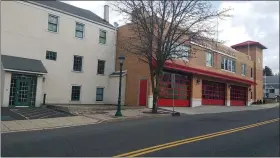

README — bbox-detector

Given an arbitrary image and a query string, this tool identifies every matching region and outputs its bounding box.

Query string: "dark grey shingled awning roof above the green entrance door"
[1,55,47,73]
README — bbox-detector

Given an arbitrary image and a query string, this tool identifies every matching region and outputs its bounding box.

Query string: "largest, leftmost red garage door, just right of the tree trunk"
[157,72,191,106]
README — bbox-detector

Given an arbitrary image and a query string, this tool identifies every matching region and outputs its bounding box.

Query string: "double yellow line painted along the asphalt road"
[115,118,279,157]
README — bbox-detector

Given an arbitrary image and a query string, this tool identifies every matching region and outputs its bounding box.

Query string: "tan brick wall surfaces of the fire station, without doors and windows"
[116,25,263,105]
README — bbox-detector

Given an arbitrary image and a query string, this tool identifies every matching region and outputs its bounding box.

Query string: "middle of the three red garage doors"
[202,80,225,105]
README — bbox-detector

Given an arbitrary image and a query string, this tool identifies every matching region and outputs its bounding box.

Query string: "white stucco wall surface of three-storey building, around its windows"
[1,1,116,104]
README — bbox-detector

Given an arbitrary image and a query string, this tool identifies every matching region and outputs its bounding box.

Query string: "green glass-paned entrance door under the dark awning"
[15,79,31,106]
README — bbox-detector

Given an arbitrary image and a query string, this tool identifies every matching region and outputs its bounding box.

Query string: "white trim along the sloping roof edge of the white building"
[20,1,116,30]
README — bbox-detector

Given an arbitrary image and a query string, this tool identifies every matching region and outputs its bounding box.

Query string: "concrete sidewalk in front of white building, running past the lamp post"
[1,108,168,133]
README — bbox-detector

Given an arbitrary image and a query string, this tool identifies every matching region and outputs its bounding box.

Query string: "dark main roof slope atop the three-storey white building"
[30,0,114,27]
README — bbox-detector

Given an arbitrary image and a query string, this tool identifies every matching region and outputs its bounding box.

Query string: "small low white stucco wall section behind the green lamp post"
[105,75,126,105]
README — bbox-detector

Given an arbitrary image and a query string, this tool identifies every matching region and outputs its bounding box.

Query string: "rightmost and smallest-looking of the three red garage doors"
[230,85,247,106]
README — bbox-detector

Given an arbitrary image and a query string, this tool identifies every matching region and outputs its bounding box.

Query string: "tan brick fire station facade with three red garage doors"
[116,24,266,107]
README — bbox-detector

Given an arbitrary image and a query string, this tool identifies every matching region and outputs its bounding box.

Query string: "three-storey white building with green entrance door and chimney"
[1,1,125,107]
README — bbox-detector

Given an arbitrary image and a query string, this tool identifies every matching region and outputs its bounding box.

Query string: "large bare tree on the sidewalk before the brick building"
[112,0,229,113]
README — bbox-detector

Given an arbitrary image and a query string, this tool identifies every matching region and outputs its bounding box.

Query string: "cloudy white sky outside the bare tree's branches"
[66,1,279,73]
